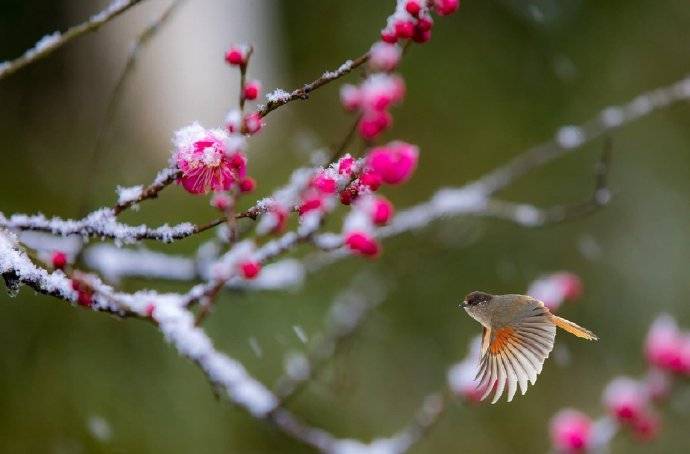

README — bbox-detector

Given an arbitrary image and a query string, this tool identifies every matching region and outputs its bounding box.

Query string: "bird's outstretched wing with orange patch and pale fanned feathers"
[476,300,556,404]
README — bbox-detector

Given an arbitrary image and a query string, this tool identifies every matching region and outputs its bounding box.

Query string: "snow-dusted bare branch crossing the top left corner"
[0,0,143,79]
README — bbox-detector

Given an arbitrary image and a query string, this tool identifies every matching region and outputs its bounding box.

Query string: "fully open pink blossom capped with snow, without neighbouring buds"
[174,124,237,194]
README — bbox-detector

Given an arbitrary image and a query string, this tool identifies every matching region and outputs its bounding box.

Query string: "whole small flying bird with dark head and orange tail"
[460,291,599,404]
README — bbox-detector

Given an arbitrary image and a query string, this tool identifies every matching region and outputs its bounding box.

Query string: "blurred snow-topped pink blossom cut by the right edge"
[645,314,690,374]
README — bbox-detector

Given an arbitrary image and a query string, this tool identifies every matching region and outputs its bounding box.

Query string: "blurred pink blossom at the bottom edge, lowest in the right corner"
[550,408,592,453]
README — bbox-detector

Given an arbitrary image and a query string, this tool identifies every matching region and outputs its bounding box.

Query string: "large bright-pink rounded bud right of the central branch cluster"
[367,142,419,184]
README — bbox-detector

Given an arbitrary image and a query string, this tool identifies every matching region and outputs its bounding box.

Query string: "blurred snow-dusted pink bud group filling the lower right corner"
[551,315,690,453]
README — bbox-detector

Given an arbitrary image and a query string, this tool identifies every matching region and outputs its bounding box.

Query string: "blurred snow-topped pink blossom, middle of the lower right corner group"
[603,377,649,423]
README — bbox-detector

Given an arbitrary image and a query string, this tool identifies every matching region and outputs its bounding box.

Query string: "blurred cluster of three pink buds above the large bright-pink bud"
[340,73,405,140]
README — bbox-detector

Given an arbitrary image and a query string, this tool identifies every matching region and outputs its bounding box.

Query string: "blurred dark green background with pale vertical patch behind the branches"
[0,0,690,453]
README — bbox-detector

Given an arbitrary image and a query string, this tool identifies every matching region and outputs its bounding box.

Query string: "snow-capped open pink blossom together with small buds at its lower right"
[173,123,254,195]
